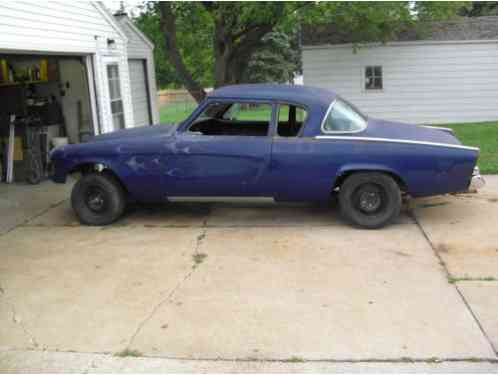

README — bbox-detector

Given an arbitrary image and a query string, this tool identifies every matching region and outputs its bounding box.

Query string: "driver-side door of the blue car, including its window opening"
[163,100,275,198]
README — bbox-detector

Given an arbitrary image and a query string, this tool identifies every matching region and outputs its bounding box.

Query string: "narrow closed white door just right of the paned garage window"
[128,59,152,126]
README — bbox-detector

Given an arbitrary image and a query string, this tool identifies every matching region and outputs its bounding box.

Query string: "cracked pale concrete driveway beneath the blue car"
[0,176,498,372]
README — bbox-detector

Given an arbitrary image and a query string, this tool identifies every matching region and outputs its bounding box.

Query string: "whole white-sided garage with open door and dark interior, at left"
[0,2,159,184]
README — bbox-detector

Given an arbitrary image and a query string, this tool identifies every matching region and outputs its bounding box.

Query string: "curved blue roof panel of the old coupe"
[208,84,336,107]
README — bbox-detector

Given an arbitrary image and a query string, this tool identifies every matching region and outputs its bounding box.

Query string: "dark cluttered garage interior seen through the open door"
[0,54,95,184]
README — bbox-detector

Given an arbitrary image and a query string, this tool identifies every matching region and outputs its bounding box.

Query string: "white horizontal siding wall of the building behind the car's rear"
[303,41,498,123]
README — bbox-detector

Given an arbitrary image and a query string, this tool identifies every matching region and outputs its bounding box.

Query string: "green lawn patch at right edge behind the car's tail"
[441,121,498,174]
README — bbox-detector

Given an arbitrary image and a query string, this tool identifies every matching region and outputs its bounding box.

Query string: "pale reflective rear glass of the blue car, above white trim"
[322,99,367,133]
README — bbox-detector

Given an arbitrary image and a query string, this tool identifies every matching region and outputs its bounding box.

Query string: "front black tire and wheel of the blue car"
[71,173,126,225]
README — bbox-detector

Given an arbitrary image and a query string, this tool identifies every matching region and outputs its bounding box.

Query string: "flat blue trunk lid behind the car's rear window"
[359,118,461,145]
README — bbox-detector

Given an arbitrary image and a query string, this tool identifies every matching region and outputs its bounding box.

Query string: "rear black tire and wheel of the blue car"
[339,172,401,229]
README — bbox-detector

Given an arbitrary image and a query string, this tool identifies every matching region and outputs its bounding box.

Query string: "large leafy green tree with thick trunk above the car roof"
[146,1,462,101]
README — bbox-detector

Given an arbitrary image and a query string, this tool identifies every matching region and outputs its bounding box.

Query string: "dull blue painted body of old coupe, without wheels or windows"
[52,85,478,201]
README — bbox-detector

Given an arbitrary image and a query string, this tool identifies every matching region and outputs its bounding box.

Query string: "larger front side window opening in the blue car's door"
[188,102,272,137]
